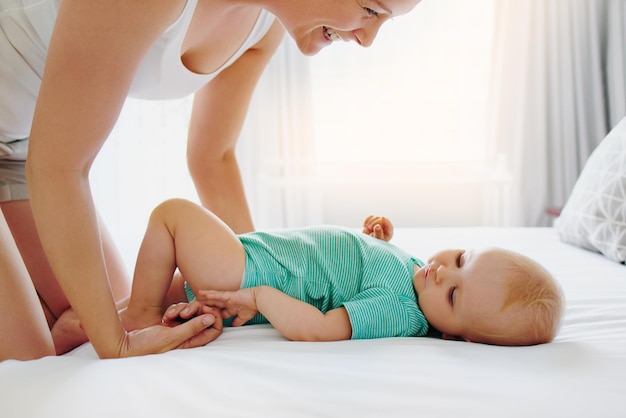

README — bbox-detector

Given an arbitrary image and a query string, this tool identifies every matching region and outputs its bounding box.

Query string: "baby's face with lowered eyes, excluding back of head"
[413,249,508,341]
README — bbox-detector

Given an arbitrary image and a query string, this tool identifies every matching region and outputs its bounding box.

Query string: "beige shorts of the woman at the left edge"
[0,138,28,202]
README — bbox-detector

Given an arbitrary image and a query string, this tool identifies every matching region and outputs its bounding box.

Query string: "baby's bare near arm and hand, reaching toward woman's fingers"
[197,286,352,341]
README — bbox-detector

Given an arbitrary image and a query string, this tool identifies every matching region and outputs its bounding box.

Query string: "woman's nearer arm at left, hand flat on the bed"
[27,0,210,358]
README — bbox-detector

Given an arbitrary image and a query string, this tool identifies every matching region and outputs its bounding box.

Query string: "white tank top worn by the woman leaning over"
[0,0,274,145]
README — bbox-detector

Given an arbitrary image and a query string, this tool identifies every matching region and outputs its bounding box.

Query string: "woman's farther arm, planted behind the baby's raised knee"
[187,21,284,233]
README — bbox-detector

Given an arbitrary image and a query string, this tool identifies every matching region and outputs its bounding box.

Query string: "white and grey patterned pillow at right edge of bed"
[554,118,626,263]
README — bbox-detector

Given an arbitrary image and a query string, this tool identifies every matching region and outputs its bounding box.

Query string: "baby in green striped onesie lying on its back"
[121,199,563,345]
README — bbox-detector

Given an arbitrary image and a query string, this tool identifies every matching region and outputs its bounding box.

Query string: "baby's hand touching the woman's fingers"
[196,288,259,327]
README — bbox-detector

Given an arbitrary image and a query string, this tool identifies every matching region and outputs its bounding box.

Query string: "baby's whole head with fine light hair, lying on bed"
[413,248,563,345]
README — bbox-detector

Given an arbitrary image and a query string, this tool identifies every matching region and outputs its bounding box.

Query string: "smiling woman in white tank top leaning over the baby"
[0,0,419,359]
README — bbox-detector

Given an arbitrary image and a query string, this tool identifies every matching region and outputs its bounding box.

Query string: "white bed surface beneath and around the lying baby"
[0,228,626,418]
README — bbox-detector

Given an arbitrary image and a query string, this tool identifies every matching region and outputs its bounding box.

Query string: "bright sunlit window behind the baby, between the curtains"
[310,0,502,226]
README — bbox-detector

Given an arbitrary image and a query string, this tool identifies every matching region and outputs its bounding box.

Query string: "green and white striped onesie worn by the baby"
[189,226,428,339]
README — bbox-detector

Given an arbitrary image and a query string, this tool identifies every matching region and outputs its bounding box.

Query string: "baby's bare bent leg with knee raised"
[122,199,245,329]
